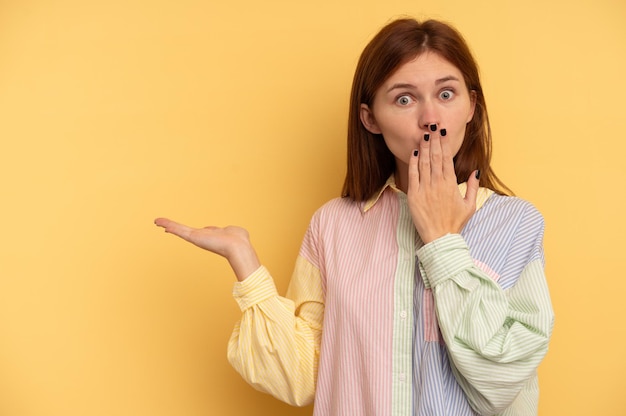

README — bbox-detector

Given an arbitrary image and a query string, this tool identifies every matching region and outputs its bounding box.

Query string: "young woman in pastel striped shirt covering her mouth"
[156,19,553,416]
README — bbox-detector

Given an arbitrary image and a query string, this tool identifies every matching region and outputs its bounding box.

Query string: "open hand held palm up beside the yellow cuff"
[154,218,261,281]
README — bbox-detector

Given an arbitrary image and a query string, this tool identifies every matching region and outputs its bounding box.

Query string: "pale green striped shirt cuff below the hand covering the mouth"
[417,234,474,289]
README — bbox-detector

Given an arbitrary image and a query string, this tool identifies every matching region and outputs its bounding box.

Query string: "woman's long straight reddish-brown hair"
[342,19,512,201]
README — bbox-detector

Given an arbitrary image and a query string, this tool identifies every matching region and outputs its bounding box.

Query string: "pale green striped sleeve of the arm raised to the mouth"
[417,220,554,415]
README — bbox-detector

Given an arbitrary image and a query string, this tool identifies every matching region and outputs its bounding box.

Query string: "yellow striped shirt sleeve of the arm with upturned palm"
[228,256,324,406]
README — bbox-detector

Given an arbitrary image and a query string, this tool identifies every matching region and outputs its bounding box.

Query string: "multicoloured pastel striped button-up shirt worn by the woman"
[228,178,553,416]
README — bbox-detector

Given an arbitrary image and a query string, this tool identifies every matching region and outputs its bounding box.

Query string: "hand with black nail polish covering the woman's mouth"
[407,130,479,244]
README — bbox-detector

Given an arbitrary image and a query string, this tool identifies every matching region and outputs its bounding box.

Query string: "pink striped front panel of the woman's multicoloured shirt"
[300,191,398,416]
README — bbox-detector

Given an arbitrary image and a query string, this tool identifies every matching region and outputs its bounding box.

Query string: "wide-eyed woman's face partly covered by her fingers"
[361,52,475,176]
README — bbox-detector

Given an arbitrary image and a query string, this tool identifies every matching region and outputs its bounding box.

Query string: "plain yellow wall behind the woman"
[0,0,626,416]
